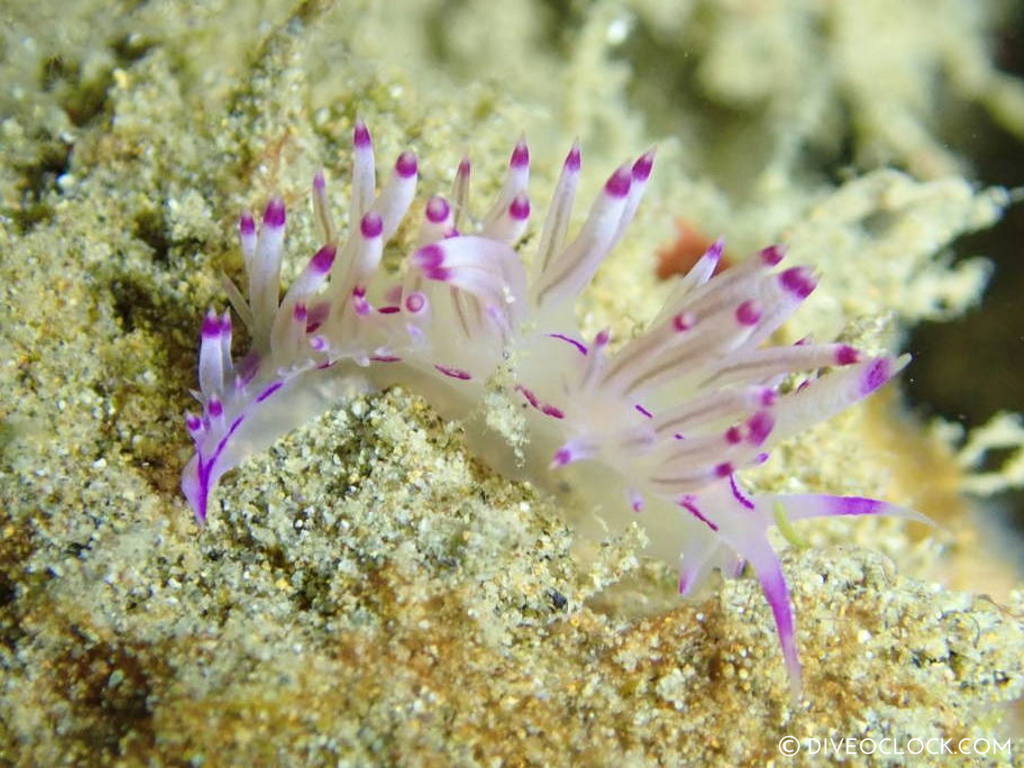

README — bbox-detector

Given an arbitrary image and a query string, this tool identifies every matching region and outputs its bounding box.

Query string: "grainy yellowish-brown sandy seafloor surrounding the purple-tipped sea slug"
[0,0,1024,766]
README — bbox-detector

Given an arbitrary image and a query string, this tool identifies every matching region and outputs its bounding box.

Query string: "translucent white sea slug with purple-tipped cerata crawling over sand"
[181,122,920,689]
